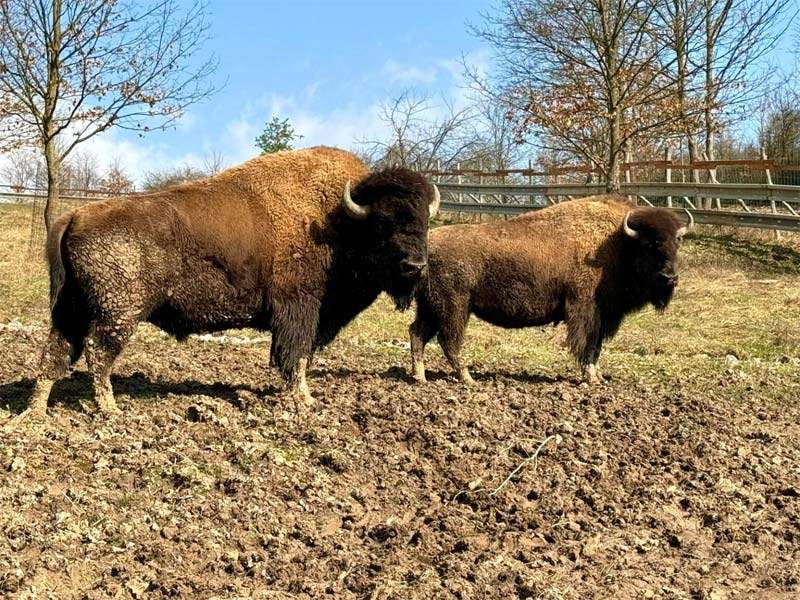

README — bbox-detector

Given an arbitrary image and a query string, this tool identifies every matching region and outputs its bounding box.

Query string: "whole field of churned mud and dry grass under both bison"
[0,204,800,600]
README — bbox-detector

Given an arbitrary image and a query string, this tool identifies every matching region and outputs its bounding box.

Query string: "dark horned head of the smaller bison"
[622,208,694,310]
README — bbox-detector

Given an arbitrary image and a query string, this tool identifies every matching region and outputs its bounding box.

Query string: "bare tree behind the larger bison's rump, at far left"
[0,0,216,229]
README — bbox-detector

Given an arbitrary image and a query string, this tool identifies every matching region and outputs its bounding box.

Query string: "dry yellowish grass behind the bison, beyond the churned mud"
[0,205,800,390]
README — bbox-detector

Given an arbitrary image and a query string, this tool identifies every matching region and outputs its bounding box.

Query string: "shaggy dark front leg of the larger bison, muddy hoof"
[270,298,319,406]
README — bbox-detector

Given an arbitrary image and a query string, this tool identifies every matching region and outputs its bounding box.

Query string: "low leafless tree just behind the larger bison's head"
[360,90,475,170]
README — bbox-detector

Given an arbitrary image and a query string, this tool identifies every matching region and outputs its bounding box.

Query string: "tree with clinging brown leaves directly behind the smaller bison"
[470,0,692,190]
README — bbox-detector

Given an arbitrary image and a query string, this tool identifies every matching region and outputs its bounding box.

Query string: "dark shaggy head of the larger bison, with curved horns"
[342,168,439,310]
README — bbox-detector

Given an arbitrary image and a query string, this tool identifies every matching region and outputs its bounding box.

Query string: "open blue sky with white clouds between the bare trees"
[84,0,491,179]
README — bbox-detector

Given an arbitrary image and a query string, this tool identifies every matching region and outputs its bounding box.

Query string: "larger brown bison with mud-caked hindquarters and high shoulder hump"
[29,148,439,414]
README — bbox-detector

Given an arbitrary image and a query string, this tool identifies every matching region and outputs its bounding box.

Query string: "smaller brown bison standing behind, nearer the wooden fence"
[409,196,693,383]
